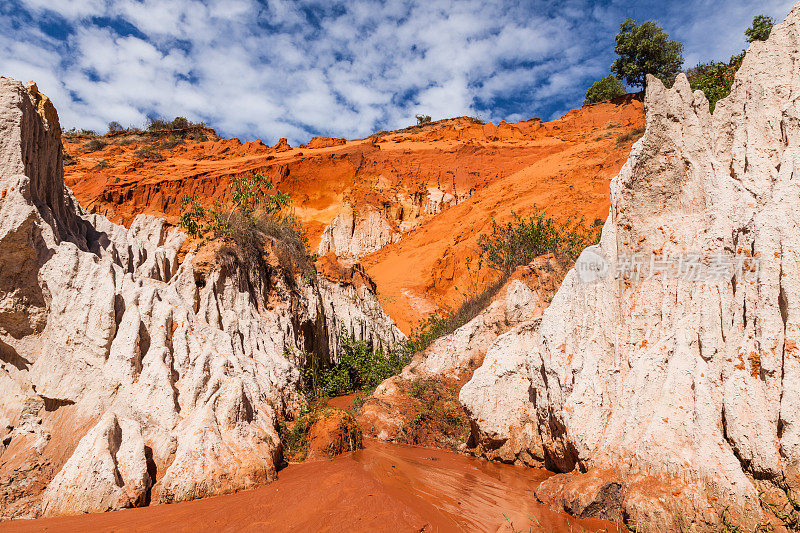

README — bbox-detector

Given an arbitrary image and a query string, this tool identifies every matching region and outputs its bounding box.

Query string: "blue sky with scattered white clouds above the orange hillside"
[0,0,793,144]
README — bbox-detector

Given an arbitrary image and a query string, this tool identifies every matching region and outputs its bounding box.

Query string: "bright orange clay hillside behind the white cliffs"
[64,97,644,332]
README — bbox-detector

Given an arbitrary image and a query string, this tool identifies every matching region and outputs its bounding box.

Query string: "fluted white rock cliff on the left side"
[0,78,402,518]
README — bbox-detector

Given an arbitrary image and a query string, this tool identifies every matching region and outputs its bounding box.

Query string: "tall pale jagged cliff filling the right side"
[460,5,800,529]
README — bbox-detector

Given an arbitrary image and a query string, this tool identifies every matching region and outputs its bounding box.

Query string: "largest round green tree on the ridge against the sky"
[611,19,683,90]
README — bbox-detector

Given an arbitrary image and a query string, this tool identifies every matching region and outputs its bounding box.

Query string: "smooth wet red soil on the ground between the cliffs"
[0,441,617,533]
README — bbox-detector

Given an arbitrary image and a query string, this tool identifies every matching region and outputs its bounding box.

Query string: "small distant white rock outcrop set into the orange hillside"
[317,204,400,257]
